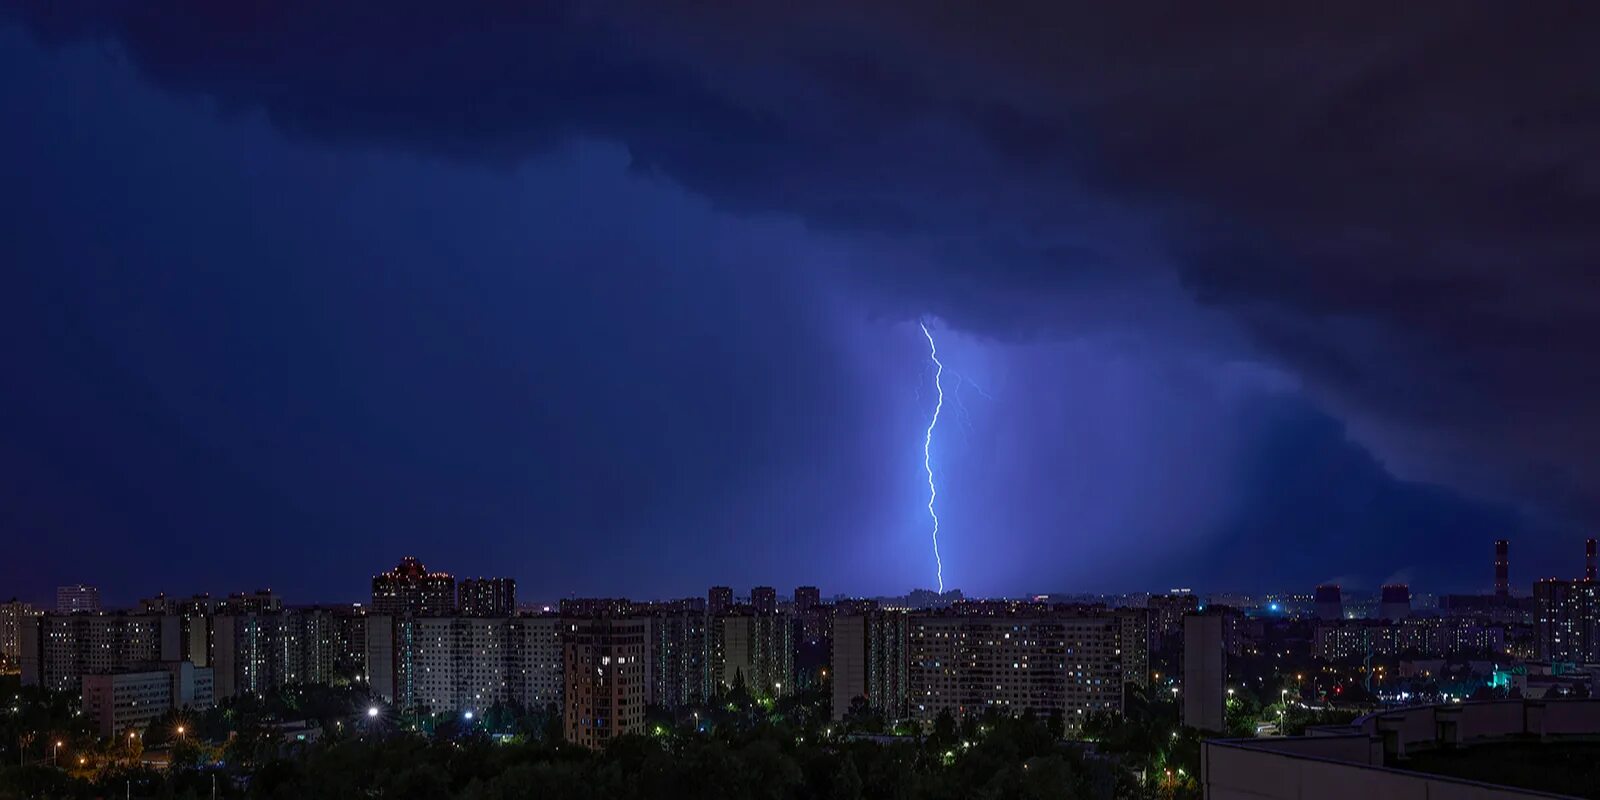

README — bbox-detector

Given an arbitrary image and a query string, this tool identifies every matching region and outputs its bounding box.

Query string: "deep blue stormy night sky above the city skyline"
[0,0,1600,603]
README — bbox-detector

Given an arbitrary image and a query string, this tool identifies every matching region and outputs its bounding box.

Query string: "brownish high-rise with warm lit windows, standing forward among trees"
[562,618,650,749]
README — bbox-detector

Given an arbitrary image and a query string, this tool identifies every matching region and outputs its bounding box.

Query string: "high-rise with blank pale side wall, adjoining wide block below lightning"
[829,611,910,722]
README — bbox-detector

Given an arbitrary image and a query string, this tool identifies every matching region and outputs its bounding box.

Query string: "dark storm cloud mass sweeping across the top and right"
[18,2,1600,522]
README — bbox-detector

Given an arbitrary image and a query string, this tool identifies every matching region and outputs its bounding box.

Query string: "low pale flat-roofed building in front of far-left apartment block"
[83,661,214,736]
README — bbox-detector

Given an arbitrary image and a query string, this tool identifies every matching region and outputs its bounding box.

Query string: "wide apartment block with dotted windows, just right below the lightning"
[907,605,1123,730]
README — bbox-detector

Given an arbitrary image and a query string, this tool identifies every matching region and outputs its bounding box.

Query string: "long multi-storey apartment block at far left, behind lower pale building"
[19,611,181,691]
